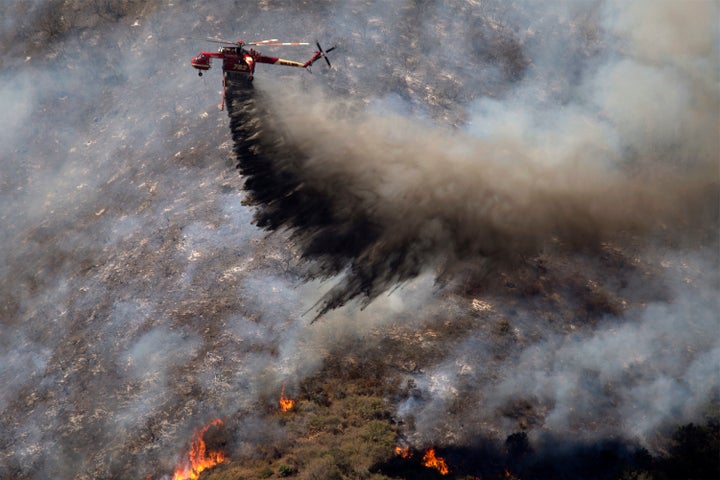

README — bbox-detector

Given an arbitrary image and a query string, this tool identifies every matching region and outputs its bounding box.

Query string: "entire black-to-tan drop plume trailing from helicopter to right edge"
[229,76,718,316]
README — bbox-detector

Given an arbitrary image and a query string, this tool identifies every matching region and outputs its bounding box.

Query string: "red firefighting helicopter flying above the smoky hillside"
[190,38,335,110]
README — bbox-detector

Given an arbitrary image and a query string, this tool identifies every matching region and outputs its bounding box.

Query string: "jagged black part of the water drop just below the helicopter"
[228,79,396,315]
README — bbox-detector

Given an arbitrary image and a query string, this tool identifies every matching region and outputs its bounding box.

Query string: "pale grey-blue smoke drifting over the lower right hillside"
[399,246,720,448]
